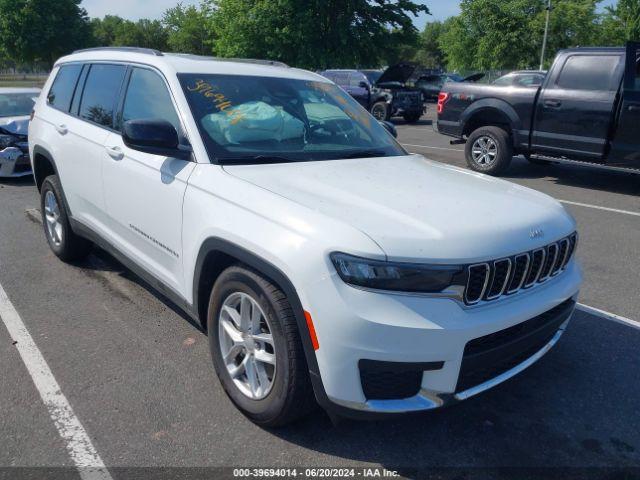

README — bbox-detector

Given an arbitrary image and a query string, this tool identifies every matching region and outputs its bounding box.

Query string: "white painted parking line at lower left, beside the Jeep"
[0,285,112,480]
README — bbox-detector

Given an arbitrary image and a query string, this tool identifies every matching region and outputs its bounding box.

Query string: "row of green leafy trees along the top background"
[0,0,640,70]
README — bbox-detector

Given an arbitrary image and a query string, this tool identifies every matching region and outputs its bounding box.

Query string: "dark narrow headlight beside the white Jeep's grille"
[330,253,464,293]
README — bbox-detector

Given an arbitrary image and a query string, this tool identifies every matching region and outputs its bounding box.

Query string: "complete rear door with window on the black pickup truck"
[531,52,624,162]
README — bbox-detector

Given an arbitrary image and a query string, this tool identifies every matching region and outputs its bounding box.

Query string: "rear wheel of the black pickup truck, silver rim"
[464,127,513,175]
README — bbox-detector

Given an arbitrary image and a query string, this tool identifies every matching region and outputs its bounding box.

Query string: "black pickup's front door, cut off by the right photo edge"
[607,42,640,168]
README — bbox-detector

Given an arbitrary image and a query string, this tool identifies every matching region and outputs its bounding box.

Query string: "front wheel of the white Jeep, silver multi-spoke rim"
[207,266,316,427]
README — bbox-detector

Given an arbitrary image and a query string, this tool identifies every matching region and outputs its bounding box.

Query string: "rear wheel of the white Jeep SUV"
[40,175,92,262]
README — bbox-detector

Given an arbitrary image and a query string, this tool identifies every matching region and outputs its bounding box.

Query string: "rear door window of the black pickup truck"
[556,55,620,91]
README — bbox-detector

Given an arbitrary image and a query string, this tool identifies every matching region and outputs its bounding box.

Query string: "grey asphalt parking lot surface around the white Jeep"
[0,105,640,478]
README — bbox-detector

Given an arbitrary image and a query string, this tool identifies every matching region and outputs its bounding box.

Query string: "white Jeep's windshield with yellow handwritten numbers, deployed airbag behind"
[179,74,406,163]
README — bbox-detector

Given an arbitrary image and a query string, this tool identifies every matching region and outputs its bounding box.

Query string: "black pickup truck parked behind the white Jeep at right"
[436,42,640,175]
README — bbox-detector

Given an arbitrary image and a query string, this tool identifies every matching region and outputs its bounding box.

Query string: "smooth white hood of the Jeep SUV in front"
[224,155,575,263]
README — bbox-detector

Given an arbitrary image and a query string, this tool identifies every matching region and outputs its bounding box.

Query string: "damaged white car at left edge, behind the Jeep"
[0,88,40,177]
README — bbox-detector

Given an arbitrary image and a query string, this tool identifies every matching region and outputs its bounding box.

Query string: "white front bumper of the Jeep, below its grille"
[302,261,582,414]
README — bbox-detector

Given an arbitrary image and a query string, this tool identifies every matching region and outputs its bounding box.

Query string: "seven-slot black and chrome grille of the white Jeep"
[464,233,578,305]
